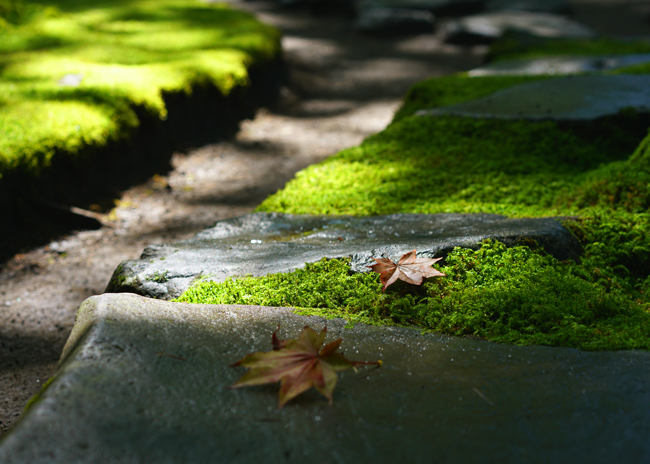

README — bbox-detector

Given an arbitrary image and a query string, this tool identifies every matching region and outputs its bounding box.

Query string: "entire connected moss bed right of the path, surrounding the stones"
[175,41,650,349]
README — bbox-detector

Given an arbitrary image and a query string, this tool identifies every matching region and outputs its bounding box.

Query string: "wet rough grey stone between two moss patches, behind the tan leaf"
[106,213,581,299]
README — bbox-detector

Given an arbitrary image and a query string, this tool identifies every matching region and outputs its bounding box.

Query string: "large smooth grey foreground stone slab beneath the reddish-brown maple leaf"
[0,295,650,464]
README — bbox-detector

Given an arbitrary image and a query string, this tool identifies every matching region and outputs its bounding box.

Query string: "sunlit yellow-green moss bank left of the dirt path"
[0,0,279,177]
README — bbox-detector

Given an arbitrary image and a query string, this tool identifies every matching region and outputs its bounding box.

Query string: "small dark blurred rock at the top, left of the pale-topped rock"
[356,7,435,35]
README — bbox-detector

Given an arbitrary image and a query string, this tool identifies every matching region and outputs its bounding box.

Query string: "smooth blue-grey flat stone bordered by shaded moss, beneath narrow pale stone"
[416,75,650,121]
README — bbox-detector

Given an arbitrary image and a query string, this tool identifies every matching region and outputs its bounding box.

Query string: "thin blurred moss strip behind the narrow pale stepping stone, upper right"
[487,32,650,61]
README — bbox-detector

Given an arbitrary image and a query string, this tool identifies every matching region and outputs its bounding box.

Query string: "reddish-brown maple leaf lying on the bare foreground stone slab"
[231,326,381,408]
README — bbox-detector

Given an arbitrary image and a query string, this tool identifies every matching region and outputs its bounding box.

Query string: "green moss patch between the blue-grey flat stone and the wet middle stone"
[258,116,650,216]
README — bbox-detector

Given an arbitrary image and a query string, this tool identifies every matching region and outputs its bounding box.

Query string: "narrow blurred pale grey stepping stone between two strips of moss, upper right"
[468,53,650,77]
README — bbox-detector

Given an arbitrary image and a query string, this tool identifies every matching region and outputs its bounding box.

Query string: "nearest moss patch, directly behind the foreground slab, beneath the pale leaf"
[177,242,650,350]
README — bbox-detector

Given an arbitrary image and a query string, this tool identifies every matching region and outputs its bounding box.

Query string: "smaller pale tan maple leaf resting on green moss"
[368,250,445,291]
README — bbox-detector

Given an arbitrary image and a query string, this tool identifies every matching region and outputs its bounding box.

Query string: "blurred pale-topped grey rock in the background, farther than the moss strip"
[443,11,595,45]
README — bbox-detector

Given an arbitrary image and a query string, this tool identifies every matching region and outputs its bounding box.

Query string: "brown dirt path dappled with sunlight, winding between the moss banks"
[0,0,650,435]
